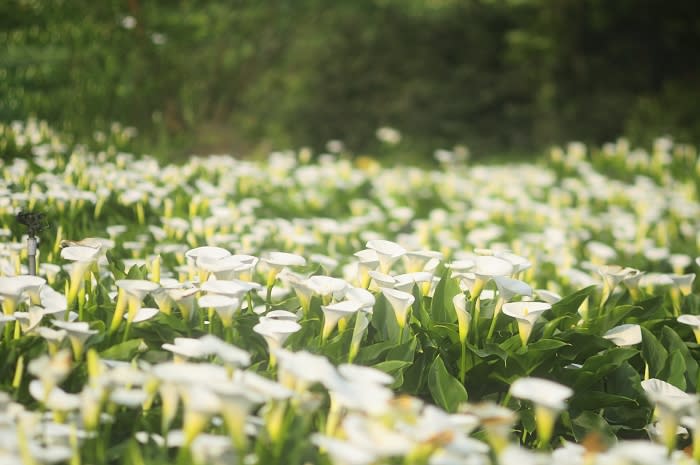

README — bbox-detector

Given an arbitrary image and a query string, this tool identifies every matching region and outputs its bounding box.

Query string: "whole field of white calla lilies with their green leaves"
[0,121,700,465]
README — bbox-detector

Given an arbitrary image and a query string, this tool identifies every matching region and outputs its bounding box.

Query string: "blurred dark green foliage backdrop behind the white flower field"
[0,0,700,158]
